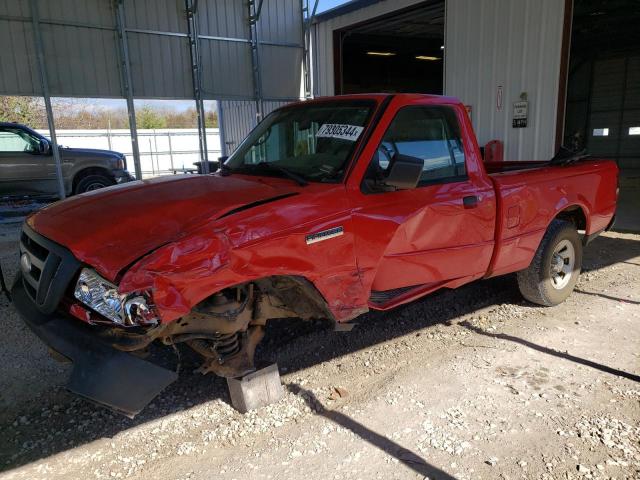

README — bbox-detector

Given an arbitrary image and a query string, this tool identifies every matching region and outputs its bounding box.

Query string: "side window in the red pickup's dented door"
[367,106,467,186]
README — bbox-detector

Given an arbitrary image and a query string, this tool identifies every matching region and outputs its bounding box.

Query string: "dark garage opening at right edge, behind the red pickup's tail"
[564,0,640,230]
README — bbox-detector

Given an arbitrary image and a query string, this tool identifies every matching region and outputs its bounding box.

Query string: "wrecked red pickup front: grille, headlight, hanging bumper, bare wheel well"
[12,225,333,416]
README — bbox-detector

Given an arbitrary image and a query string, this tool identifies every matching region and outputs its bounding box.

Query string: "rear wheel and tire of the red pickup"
[518,220,582,307]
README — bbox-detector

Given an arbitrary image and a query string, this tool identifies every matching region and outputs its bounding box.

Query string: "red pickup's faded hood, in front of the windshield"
[27,175,295,281]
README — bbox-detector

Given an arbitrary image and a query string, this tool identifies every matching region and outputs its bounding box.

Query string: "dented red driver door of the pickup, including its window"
[352,104,495,292]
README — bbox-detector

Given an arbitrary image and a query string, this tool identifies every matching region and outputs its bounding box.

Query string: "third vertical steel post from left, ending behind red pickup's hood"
[185,0,209,173]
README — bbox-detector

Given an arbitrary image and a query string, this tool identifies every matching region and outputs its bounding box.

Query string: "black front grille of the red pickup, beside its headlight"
[20,224,80,313]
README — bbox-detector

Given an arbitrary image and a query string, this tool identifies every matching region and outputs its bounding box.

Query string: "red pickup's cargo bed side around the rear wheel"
[485,159,618,276]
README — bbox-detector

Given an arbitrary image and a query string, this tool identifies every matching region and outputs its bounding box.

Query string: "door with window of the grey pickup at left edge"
[0,126,57,195]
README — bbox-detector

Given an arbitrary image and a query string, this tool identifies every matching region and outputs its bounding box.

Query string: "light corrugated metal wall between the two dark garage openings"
[445,0,564,160]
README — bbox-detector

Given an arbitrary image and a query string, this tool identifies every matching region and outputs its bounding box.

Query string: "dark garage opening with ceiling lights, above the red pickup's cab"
[334,1,445,94]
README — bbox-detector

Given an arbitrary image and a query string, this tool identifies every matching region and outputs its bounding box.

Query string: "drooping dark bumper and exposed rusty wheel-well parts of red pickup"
[12,268,327,417]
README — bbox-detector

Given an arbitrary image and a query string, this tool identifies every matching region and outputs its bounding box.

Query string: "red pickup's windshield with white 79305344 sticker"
[224,100,375,182]
